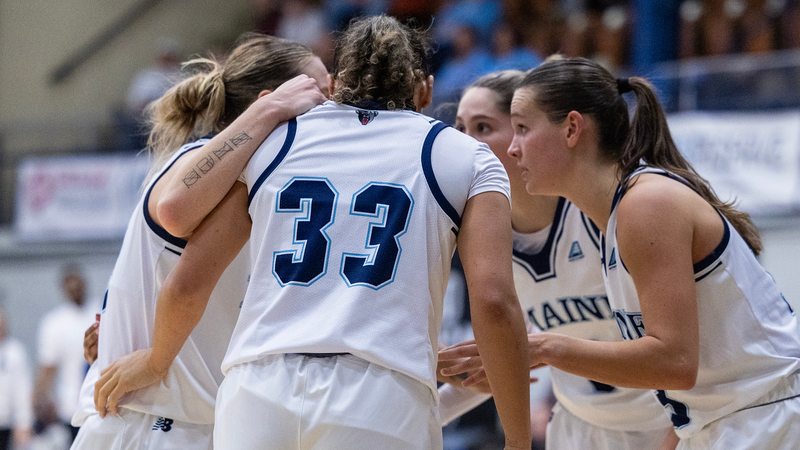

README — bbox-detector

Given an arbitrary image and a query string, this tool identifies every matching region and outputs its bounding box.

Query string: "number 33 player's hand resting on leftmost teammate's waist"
[94,348,167,417]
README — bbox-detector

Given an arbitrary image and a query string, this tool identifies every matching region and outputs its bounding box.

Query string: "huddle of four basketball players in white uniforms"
[67,16,800,450]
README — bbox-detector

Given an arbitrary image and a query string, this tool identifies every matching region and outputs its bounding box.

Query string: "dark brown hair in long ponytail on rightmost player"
[519,58,762,255]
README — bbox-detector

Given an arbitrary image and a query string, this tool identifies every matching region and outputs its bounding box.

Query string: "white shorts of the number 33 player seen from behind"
[214,354,442,450]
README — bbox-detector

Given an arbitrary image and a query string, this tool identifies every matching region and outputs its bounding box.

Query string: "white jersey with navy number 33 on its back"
[223,101,509,398]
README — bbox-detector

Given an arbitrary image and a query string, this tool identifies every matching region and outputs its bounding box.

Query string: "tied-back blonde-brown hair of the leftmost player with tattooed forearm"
[146,33,314,180]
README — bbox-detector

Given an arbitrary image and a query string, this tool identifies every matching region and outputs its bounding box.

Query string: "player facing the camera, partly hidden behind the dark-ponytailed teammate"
[442,70,677,450]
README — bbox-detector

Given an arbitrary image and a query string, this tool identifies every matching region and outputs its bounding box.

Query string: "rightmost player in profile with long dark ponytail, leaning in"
[438,58,800,449]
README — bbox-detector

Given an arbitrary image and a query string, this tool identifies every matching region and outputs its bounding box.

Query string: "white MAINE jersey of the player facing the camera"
[514,198,670,431]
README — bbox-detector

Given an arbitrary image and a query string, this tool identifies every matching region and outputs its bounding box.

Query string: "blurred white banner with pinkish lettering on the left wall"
[14,155,150,241]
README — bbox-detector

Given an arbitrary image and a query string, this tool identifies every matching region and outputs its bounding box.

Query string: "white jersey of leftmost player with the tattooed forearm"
[87,139,249,424]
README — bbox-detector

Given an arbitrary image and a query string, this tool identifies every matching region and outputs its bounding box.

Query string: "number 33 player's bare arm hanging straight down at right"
[458,192,531,449]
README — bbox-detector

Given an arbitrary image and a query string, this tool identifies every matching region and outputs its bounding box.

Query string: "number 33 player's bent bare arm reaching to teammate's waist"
[95,183,250,417]
